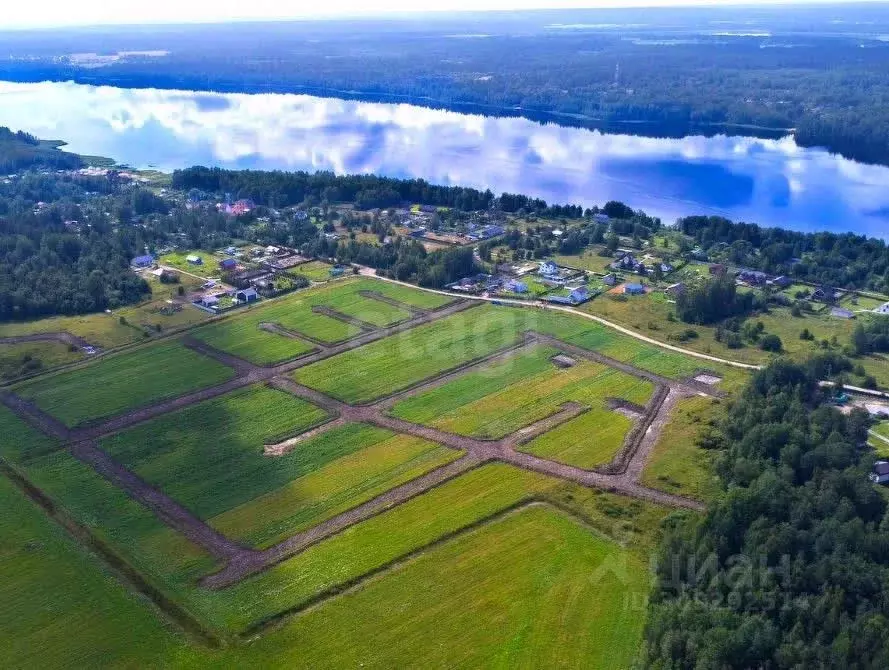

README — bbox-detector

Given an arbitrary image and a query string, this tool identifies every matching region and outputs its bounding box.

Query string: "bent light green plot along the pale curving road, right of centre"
[293,305,701,403]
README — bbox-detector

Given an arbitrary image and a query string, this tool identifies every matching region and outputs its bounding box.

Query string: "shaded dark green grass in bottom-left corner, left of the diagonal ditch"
[0,476,184,669]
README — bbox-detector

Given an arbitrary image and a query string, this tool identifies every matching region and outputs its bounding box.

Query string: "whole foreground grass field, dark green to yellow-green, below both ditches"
[0,464,648,668]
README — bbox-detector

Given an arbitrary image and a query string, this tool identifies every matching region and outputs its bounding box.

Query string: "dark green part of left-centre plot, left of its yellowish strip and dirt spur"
[100,386,338,519]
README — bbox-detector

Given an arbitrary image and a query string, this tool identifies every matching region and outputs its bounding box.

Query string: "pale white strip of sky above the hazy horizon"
[0,0,884,28]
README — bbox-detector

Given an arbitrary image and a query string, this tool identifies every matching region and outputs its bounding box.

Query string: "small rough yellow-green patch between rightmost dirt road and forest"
[642,398,720,501]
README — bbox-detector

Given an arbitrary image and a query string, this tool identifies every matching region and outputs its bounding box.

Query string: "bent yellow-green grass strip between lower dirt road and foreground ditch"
[195,464,669,631]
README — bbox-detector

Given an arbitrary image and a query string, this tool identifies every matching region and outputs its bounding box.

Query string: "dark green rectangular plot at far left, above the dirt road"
[15,340,234,426]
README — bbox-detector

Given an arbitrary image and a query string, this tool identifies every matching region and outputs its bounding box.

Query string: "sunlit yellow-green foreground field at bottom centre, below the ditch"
[217,506,649,668]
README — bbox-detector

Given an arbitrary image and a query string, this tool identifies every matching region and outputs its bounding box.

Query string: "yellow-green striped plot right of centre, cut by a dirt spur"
[392,347,653,468]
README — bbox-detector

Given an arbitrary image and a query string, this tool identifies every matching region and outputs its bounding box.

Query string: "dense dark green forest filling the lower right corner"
[645,359,889,670]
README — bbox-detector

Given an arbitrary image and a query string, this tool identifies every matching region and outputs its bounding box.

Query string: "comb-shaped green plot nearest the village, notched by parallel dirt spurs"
[194,279,449,365]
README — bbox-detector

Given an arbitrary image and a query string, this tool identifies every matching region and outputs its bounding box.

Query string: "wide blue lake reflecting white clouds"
[0,82,889,237]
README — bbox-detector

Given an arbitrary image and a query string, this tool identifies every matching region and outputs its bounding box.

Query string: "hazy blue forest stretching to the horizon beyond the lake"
[0,6,889,163]
